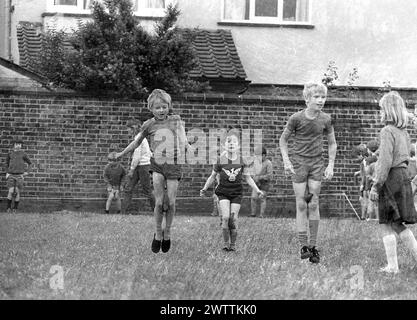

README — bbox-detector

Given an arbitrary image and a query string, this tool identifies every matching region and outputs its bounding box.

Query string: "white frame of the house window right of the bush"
[220,0,313,25]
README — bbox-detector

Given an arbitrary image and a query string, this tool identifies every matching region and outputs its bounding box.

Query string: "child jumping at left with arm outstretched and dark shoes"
[117,89,191,253]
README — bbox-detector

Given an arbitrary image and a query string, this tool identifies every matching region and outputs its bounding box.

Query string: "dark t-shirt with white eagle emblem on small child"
[213,155,248,196]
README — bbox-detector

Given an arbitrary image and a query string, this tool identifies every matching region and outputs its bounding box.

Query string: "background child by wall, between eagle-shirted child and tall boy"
[251,147,272,218]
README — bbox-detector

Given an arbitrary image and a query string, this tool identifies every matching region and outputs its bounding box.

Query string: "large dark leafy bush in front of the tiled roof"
[37,0,207,96]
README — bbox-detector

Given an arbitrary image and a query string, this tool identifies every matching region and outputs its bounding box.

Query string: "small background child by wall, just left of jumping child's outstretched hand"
[104,152,126,214]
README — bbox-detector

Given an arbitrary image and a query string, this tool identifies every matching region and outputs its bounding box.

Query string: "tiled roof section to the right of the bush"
[183,29,246,80]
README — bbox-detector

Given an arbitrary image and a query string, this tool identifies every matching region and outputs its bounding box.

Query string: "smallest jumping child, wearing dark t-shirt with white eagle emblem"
[200,131,263,251]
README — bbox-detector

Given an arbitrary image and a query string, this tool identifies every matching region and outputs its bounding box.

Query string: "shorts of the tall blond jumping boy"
[292,156,324,183]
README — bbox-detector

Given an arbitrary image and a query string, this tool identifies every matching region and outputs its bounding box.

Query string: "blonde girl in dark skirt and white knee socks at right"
[370,91,417,273]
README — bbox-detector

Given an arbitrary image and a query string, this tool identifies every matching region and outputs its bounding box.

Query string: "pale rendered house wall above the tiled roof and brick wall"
[0,0,417,87]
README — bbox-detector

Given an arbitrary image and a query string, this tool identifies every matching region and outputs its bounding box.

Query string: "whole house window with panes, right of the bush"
[222,0,310,24]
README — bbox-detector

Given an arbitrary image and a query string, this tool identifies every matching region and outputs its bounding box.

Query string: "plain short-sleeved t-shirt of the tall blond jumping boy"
[287,109,333,158]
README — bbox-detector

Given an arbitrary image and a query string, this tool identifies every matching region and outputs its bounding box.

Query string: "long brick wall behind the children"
[0,92,416,214]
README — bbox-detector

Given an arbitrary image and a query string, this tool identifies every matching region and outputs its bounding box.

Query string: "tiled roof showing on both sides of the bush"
[17,22,246,81]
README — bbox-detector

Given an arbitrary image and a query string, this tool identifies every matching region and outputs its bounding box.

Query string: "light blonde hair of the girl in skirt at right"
[379,91,408,129]
